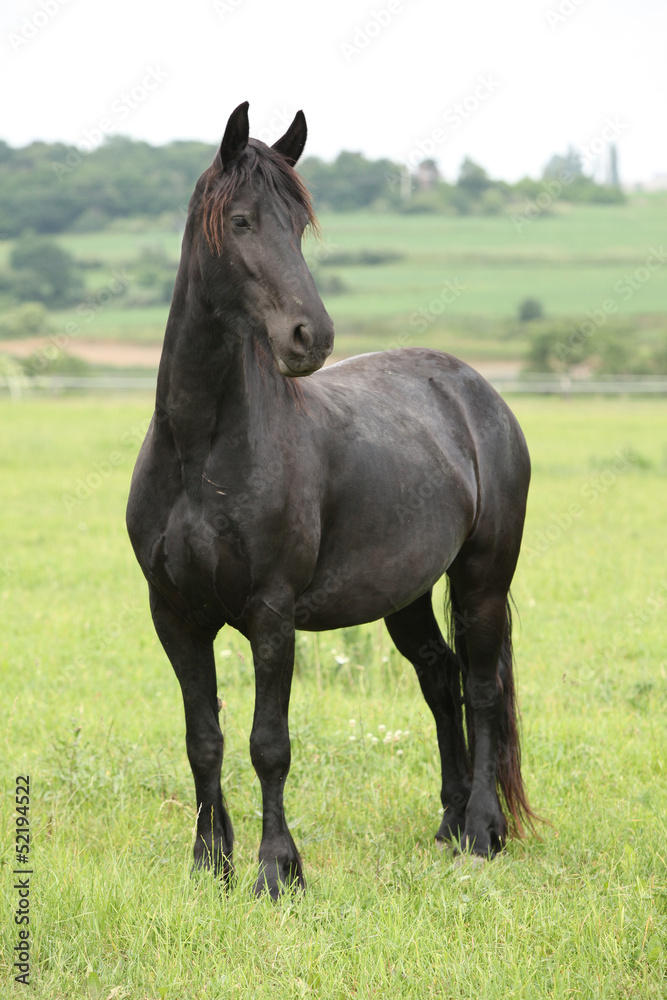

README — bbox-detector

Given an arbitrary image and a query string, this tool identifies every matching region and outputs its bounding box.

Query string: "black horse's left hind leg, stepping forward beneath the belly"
[385,591,470,840]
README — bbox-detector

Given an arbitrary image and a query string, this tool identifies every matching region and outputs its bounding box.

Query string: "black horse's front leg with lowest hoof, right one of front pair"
[248,602,305,899]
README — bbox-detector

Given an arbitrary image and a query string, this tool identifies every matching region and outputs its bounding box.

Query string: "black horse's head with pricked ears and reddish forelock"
[190,102,334,376]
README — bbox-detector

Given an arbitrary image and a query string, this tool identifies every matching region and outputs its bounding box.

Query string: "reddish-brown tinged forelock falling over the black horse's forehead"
[200,139,319,254]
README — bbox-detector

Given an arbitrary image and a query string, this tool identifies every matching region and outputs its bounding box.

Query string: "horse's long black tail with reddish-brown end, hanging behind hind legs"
[449,586,540,837]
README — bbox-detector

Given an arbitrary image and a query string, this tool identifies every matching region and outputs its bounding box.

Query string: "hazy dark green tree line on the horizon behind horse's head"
[0,136,624,239]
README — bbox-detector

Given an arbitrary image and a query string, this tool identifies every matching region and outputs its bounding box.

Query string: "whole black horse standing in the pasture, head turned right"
[127,103,533,897]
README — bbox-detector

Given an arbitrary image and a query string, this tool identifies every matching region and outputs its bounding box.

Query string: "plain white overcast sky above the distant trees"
[0,0,667,181]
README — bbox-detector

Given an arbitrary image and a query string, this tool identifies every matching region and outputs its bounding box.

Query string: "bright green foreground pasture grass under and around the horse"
[0,397,667,1000]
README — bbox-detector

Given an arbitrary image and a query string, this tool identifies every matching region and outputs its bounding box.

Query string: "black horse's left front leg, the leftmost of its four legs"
[150,587,234,882]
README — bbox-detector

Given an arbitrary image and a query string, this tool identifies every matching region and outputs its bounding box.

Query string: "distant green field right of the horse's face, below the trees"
[310,198,667,327]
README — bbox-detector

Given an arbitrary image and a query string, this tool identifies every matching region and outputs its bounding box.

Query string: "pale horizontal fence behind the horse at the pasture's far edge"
[0,373,667,399]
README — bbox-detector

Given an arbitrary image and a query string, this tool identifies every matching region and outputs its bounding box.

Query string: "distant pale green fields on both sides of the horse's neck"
[5,193,667,370]
